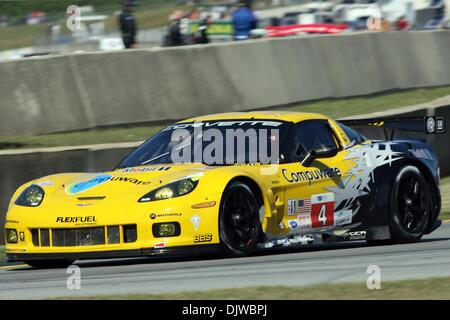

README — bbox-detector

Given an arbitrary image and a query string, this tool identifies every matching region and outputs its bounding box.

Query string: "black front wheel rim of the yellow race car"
[223,189,258,250]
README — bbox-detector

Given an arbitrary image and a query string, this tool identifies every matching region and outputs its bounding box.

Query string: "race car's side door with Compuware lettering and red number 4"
[280,120,352,234]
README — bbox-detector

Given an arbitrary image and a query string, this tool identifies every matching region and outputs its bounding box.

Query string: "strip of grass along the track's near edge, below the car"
[62,277,450,300]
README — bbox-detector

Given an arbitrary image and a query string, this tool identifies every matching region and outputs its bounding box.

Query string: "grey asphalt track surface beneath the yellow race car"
[0,224,450,299]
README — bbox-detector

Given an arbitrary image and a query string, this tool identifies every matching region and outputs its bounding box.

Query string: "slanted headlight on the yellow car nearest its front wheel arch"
[139,176,199,202]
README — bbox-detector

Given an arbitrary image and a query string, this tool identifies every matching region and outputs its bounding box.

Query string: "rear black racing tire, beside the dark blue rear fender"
[390,165,431,243]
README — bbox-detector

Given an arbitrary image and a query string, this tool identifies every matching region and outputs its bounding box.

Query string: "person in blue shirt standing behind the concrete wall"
[232,0,257,40]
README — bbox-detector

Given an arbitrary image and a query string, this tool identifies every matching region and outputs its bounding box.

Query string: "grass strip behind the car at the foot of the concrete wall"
[0,87,450,149]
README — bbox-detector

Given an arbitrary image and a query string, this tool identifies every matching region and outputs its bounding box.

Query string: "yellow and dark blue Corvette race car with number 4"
[5,112,445,267]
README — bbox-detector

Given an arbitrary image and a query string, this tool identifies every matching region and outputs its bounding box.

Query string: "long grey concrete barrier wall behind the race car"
[0,31,450,135]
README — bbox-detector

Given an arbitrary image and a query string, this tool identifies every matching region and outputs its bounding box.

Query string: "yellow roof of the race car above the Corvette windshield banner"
[178,111,329,123]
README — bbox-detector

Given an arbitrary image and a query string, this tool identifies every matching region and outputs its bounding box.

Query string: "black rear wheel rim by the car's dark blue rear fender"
[397,173,428,233]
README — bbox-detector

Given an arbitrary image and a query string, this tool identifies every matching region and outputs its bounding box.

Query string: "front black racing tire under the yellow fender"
[219,181,262,257]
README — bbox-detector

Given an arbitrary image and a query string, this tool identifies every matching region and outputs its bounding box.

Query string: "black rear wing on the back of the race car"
[338,116,445,140]
